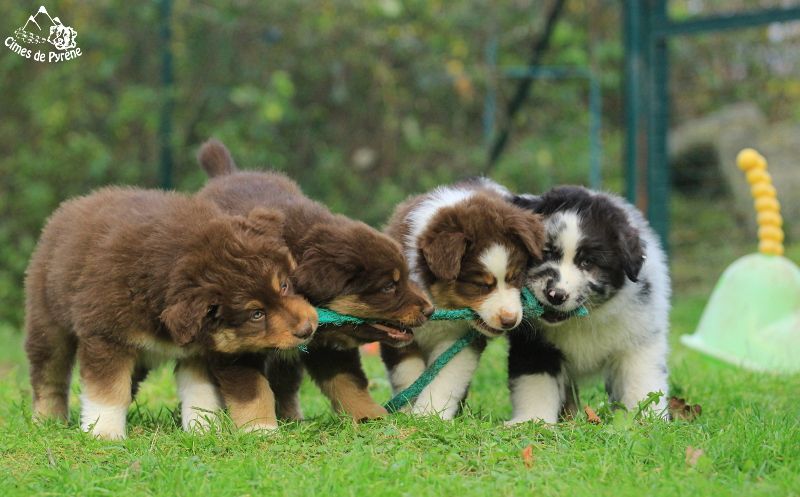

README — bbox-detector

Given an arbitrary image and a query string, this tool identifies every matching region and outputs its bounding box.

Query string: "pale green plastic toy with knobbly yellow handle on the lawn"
[681,148,800,373]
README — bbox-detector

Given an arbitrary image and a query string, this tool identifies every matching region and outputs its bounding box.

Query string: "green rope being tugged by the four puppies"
[312,288,589,412]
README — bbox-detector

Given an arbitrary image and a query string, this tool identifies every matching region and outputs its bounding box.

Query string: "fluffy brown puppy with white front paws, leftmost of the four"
[25,188,317,439]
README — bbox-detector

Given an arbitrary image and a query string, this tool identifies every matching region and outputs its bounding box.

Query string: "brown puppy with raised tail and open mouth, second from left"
[198,140,433,419]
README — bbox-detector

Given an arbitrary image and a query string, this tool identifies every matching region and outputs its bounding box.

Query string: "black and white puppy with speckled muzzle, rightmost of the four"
[508,186,670,424]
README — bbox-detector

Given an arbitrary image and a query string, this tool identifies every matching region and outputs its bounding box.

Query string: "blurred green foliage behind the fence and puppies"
[0,0,800,326]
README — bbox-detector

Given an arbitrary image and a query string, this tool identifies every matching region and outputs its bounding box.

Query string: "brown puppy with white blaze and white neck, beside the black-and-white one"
[381,180,544,419]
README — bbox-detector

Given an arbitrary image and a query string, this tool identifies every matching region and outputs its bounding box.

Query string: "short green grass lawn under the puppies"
[0,197,800,497]
